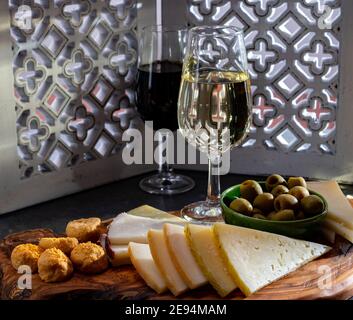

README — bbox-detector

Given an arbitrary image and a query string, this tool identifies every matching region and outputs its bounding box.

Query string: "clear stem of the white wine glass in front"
[206,157,221,204]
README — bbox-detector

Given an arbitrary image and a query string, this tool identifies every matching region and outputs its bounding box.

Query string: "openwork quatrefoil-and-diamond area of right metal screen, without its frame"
[188,0,342,156]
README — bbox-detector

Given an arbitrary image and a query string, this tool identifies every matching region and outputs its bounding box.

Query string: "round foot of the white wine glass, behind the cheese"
[181,201,224,224]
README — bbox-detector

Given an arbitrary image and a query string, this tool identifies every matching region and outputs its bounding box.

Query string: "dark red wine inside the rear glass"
[136,61,182,131]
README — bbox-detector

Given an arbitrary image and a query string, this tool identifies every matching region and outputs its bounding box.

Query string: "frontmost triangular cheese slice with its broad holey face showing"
[214,223,331,296]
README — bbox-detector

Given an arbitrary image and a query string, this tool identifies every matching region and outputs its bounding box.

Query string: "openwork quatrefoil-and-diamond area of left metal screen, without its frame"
[9,0,137,179]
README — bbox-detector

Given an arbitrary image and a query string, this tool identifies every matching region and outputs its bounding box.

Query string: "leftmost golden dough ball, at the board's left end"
[11,243,43,273]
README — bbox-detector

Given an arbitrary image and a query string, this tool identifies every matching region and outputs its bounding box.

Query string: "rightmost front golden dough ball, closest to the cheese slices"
[71,242,108,274]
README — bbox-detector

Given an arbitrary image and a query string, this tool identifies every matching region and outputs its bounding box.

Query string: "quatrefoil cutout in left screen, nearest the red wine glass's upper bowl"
[109,42,136,76]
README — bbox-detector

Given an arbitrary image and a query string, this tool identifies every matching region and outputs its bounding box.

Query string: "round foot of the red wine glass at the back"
[140,172,195,195]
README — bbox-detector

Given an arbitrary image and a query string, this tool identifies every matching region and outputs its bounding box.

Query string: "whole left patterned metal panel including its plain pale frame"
[0,0,146,213]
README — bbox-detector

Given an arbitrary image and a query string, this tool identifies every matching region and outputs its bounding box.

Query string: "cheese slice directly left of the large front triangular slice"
[185,224,237,297]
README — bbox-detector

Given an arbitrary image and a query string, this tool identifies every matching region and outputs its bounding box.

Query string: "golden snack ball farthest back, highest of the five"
[66,218,102,242]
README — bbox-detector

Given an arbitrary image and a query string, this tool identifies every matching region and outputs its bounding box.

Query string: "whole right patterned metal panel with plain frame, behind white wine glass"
[173,0,353,181]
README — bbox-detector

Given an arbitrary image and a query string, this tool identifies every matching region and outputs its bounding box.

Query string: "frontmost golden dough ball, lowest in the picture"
[38,248,74,282]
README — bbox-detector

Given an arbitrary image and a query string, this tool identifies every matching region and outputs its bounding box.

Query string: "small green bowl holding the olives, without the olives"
[221,182,328,239]
